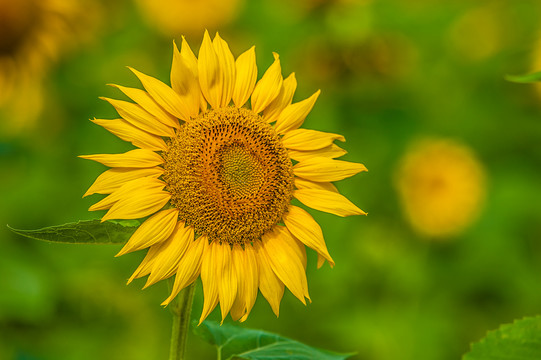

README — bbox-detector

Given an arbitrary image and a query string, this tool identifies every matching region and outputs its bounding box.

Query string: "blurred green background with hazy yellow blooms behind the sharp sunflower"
[0,0,541,360]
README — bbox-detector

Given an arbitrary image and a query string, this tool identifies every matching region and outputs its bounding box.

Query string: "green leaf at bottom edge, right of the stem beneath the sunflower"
[194,321,351,360]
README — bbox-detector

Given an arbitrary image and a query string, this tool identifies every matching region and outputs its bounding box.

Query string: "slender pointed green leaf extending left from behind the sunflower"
[8,219,140,244]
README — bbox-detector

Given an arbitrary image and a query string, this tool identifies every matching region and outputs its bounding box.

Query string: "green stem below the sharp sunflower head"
[169,282,195,360]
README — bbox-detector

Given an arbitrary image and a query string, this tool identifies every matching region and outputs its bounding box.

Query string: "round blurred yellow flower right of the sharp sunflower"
[395,139,486,237]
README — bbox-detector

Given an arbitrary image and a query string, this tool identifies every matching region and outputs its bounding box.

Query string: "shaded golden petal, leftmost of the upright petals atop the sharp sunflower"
[171,42,201,118]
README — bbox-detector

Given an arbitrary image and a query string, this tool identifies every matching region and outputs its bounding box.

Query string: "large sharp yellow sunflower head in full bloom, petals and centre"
[81,32,366,321]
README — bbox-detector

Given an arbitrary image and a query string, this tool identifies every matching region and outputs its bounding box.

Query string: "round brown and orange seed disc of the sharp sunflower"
[163,107,293,244]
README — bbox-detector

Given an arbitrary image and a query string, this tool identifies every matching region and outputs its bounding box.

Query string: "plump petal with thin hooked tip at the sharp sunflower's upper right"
[252,53,283,114]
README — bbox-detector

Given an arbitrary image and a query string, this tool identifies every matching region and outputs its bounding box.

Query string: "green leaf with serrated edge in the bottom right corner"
[462,316,541,360]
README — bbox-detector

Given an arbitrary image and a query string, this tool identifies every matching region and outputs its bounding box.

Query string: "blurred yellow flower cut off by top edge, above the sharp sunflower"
[137,0,244,37]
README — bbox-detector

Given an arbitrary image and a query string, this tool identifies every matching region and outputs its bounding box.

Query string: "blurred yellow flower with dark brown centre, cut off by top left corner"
[0,0,97,136]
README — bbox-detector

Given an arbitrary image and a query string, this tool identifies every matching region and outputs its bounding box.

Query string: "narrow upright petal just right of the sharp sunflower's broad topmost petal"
[212,33,236,107]
